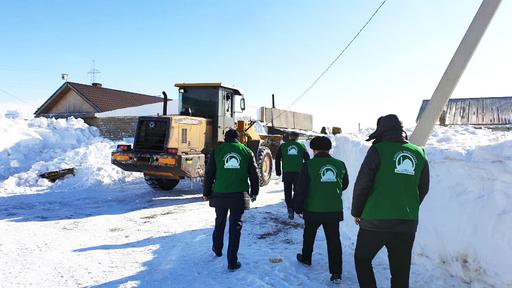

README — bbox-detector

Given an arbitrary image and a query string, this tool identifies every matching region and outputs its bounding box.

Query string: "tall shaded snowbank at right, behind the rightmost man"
[333,127,512,287]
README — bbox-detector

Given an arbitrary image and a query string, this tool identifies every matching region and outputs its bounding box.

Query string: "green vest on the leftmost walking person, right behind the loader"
[213,143,253,193]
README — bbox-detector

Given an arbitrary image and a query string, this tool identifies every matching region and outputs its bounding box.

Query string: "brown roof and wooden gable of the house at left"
[34,82,163,118]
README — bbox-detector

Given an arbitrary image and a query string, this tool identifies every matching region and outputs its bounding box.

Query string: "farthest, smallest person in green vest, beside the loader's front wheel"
[276,132,309,220]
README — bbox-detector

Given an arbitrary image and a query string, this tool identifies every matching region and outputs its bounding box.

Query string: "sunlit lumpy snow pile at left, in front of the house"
[0,116,137,196]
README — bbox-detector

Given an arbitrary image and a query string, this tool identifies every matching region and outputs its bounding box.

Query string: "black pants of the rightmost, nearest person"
[354,229,416,288]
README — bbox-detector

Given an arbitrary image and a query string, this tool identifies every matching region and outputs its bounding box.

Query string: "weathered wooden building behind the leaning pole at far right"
[416,97,512,126]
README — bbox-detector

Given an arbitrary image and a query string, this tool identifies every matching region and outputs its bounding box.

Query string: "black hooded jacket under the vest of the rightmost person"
[352,131,429,232]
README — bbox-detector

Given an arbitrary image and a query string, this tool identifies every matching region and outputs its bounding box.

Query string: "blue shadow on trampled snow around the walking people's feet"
[74,203,357,288]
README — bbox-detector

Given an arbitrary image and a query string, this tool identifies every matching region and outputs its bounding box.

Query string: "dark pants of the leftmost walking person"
[212,207,244,265]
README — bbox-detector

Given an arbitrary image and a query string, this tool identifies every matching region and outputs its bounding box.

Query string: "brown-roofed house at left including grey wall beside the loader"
[34,82,168,139]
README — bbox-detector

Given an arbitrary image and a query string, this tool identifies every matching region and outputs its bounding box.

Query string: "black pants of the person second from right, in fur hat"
[302,219,342,275]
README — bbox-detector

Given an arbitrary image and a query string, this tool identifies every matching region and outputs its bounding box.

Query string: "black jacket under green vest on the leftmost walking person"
[203,141,260,209]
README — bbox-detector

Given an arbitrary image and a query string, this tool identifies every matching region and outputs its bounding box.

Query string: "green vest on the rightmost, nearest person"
[361,142,427,220]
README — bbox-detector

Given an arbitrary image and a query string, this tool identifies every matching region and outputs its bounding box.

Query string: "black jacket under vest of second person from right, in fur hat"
[293,152,349,222]
